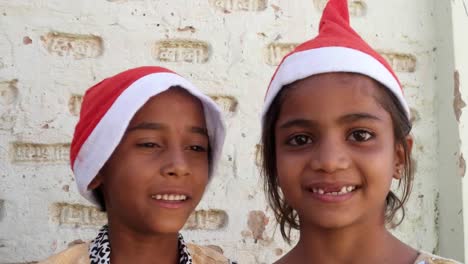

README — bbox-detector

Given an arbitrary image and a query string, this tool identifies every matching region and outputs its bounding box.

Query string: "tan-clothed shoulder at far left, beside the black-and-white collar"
[38,243,90,264]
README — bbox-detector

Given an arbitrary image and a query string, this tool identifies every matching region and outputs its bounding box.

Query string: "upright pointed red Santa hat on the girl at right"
[262,0,410,122]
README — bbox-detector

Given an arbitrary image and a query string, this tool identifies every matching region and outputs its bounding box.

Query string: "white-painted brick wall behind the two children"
[0,0,460,263]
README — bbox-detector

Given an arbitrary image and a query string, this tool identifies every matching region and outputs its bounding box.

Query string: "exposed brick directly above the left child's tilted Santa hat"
[153,39,211,63]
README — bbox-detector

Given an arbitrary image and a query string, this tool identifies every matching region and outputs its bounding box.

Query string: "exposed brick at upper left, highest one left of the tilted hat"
[41,32,103,59]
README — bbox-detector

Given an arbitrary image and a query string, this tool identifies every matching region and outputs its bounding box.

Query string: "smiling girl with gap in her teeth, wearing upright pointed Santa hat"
[262,0,455,264]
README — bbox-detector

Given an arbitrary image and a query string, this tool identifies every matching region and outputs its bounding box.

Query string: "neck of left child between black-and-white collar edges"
[109,219,179,264]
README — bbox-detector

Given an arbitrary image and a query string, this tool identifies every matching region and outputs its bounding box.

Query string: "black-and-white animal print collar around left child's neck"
[89,225,192,264]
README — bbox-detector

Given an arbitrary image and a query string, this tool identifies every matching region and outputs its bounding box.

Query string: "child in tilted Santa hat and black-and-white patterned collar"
[40,67,228,264]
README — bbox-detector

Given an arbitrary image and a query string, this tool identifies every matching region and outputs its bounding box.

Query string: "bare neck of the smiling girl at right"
[285,216,417,264]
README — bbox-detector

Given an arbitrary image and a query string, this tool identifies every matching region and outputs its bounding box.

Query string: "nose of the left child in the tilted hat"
[161,149,190,177]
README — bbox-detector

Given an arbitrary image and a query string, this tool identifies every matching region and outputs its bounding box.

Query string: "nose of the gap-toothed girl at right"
[311,136,350,173]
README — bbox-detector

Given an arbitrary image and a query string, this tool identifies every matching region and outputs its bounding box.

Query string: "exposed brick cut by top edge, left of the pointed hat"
[209,0,268,13]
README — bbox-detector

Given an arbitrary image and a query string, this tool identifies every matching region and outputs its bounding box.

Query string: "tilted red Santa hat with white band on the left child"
[70,66,225,205]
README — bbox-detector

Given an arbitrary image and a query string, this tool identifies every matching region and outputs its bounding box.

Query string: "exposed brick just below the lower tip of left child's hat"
[51,203,107,227]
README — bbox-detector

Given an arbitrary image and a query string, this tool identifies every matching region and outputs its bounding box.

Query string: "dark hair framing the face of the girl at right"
[261,74,414,243]
